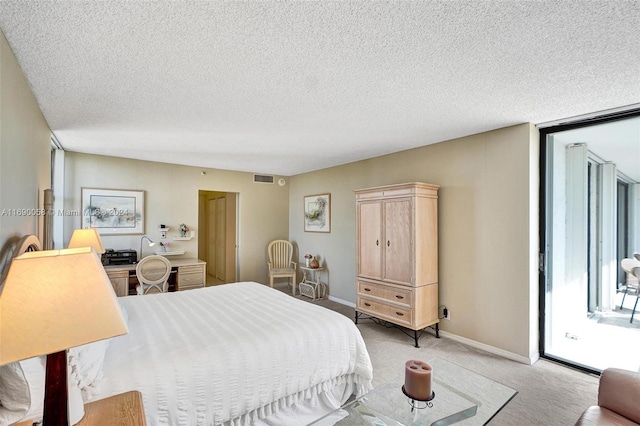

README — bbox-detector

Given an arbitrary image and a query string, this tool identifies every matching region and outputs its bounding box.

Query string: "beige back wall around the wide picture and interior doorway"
[64,152,289,283]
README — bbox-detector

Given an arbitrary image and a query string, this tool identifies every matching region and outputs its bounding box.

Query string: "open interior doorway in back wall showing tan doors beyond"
[198,190,239,286]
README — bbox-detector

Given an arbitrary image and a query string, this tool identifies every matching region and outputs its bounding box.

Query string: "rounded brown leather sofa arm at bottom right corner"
[598,368,640,423]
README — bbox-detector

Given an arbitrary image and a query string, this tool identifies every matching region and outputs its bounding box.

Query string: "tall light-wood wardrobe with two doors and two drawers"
[355,182,439,347]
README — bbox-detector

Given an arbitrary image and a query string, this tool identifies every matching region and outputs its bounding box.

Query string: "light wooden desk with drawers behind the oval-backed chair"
[104,258,207,297]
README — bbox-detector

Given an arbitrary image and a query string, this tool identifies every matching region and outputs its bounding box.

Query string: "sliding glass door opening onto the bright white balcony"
[540,113,640,372]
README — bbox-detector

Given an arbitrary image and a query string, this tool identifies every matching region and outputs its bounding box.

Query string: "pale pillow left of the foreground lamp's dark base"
[0,356,46,425]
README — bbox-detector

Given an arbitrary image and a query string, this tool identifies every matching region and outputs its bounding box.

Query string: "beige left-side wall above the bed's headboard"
[0,33,51,272]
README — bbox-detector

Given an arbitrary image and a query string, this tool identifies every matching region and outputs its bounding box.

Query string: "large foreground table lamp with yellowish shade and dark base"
[0,247,128,426]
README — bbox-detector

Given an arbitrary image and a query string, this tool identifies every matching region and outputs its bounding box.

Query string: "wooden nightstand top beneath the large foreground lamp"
[14,391,147,426]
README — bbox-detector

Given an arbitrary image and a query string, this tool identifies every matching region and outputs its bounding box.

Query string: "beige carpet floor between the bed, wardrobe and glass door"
[278,285,598,426]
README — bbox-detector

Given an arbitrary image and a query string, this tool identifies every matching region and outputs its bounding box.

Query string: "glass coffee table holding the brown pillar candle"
[312,358,518,426]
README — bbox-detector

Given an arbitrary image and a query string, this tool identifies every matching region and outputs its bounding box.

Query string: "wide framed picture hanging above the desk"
[81,188,144,235]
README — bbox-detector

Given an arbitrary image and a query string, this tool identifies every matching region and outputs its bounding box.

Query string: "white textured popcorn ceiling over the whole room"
[0,0,640,176]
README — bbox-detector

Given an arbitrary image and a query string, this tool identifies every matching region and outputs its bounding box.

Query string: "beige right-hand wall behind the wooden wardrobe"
[289,124,538,358]
